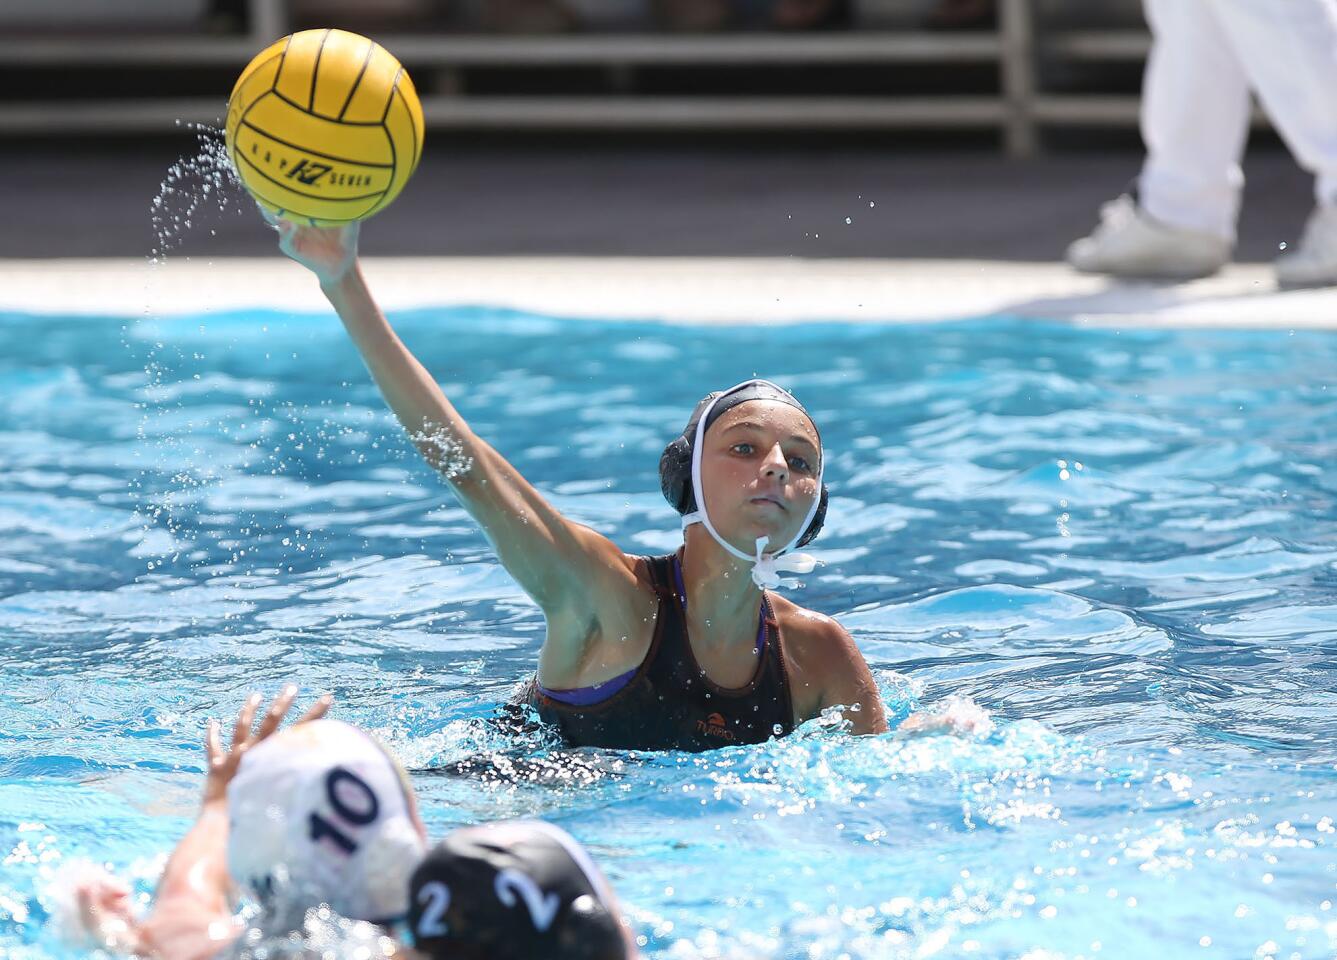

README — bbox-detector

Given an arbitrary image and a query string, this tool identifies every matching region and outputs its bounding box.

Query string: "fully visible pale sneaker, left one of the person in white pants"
[1067,194,1230,279]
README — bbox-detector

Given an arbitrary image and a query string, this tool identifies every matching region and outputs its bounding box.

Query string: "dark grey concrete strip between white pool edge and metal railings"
[0,135,1312,262]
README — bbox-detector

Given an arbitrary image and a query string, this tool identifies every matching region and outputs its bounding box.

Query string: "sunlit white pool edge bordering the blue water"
[0,254,1337,330]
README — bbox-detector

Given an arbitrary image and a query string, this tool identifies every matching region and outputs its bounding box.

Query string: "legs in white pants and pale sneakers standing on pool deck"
[1068,0,1337,283]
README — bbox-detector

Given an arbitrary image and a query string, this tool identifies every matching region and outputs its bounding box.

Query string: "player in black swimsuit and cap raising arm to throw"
[277,222,886,750]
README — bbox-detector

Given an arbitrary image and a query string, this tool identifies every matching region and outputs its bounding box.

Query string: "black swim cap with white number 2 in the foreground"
[409,820,627,960]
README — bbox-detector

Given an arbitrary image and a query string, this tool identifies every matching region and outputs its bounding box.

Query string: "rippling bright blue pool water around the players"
[0,309,1337,960]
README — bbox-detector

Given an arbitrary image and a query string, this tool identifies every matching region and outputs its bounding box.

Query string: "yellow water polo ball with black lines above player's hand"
[223,29,422,226]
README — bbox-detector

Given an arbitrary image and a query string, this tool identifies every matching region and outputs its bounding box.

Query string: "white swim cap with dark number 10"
[227,719,425,925]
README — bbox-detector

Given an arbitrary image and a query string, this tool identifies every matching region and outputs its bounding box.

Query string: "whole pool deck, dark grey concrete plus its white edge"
[0,138,1337,329]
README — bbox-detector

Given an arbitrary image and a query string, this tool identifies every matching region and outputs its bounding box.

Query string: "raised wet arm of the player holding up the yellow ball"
[275,221,626,638]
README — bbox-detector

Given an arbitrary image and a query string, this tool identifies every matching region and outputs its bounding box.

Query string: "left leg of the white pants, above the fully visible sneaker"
[1138,0,1251,245]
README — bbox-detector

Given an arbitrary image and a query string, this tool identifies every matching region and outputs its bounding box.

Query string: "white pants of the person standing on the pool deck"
[1138,0,1337,241]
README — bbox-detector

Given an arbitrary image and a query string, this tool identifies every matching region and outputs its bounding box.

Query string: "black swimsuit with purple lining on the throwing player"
[521,555,794,751]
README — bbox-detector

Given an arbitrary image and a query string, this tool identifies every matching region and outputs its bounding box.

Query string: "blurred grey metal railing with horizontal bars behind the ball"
[0,0,1171,156]
